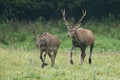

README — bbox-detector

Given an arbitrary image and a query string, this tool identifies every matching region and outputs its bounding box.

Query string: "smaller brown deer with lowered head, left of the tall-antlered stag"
[36,32,60,68]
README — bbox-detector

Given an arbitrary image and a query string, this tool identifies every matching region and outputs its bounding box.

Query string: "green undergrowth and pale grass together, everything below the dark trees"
[0,20,120,80]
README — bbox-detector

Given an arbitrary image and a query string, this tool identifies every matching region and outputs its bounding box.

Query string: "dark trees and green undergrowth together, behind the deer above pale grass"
[0,0,120,51]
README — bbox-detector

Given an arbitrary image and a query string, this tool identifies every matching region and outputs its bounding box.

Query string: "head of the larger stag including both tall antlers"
[61,9,86,37]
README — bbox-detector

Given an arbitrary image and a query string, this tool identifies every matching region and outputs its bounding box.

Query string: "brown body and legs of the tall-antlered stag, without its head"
[70,28,95,64]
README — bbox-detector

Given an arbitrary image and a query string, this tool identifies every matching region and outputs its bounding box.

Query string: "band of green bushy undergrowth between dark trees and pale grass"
[0,19,120,51]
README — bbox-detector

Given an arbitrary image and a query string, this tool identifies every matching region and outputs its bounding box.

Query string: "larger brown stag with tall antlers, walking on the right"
[61,9,95,64]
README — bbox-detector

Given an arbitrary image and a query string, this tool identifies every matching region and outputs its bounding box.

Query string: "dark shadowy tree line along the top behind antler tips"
[0,0,120,20]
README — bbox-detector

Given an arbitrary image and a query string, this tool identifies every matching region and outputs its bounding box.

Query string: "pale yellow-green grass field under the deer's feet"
[0,48,120,80]
